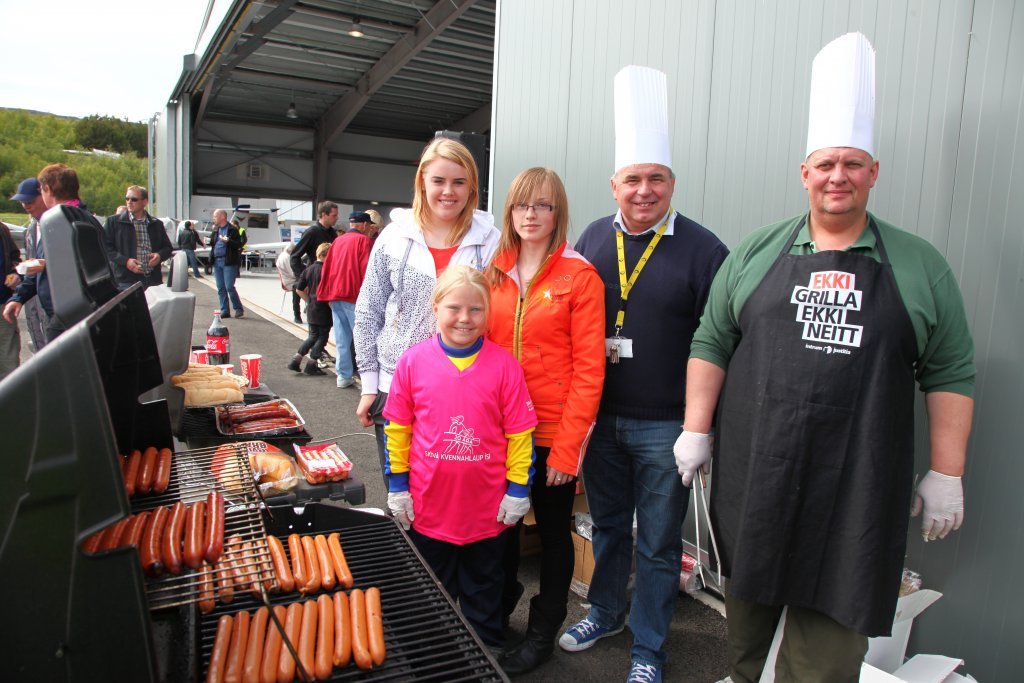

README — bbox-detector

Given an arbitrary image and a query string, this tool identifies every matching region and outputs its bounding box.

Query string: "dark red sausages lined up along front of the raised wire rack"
[82,490,224,577]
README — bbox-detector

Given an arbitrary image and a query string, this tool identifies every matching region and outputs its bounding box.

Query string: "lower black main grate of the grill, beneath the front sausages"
[200,516,508,682]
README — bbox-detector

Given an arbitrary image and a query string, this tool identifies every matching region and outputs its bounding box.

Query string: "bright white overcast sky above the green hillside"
[0,0,231,121]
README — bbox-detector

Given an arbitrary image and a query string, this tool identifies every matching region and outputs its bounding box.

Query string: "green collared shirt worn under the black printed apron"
[690,211,975,396]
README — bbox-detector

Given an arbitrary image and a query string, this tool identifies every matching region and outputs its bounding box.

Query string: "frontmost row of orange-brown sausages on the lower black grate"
[206,588,386,683]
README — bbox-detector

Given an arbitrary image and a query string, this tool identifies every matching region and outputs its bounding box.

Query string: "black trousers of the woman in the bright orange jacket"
[503,445,575,625]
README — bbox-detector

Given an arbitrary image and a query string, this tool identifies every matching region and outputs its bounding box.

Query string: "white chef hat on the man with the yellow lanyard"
[614,66,672,171]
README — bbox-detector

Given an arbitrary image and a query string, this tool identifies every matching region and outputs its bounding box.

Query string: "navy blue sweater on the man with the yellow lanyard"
[575,214,729,424]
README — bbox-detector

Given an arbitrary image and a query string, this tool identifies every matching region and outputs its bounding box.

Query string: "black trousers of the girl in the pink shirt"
[409,527,516,647]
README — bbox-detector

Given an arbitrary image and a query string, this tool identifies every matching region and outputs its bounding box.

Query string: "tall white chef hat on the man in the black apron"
[807,33,874,157]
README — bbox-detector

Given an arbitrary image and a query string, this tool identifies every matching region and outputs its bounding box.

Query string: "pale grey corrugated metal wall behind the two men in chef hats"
[492,0,1024,681]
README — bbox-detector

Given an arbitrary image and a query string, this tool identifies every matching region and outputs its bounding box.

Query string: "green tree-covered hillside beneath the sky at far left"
[0,109,147,215]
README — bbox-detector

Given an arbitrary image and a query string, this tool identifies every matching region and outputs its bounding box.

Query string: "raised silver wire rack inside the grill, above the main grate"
[131,443,273,610]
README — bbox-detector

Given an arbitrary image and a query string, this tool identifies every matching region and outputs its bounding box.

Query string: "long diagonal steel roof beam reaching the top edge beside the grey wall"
[317,0,476,148]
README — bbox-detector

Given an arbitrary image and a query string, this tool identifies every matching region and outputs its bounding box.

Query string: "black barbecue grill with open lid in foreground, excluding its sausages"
[0,274,507,683]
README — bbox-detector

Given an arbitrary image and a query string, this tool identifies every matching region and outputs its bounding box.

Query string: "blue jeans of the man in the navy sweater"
[583,413,689,666]
